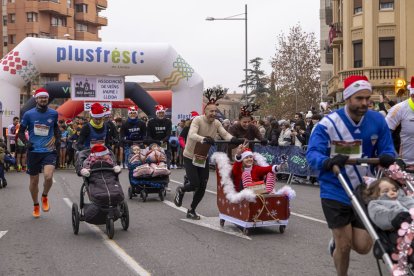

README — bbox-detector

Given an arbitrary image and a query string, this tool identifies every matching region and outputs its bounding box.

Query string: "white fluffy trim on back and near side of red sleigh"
[211,152,256,203]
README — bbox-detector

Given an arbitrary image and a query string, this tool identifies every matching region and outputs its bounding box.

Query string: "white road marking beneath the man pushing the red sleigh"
[163,200,252,240]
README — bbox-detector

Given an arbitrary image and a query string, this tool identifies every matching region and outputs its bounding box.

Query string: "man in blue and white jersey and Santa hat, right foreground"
[306,76,395,275]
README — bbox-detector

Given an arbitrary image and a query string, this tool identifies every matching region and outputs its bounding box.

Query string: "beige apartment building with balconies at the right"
[326,0,414,102]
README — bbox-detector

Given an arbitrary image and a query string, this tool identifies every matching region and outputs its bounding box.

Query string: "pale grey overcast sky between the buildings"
[100,0,320,92]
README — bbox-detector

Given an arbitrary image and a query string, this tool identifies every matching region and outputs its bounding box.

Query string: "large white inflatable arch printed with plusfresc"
[0,37,203,126]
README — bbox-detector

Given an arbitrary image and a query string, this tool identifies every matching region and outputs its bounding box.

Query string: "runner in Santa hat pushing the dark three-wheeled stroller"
[76,103,112,150]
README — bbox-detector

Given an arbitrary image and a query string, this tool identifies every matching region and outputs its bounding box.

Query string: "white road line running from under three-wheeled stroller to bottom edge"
[63,197,151,276]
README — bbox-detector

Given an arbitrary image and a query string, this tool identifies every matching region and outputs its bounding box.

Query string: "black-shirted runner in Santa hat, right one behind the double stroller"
[147,105,172,169]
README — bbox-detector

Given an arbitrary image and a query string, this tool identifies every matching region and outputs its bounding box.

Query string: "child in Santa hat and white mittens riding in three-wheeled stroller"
[80,144,121,177]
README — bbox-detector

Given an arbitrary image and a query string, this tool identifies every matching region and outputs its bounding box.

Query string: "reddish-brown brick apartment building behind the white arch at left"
[0,0,108,103]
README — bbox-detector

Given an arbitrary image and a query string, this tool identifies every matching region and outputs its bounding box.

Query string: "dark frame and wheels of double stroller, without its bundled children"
[125,142,170,202]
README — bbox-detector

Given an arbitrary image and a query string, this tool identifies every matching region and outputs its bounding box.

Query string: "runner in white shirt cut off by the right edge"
[385,76,414,171]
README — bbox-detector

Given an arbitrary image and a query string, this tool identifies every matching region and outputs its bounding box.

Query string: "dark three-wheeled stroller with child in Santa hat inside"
[72,144,129,238]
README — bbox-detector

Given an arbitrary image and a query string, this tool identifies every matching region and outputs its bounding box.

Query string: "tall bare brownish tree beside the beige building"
[262,24,320,118]
